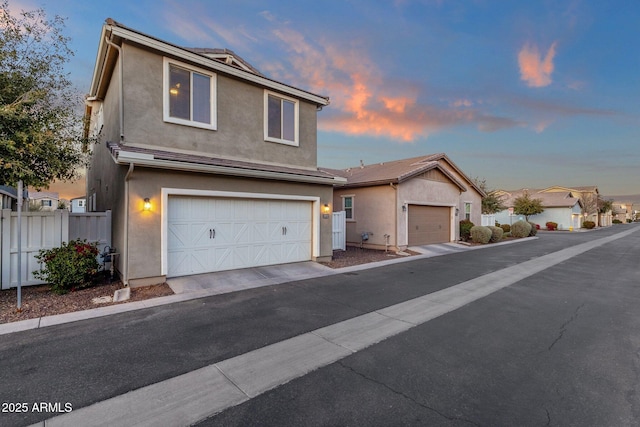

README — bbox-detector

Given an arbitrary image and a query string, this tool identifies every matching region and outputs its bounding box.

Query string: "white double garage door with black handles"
[167,196,312,277]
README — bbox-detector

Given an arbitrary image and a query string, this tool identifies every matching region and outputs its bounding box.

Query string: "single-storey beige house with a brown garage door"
[325,154,485,250]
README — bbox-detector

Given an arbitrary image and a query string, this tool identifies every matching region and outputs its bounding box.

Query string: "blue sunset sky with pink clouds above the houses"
[9,0,640,195]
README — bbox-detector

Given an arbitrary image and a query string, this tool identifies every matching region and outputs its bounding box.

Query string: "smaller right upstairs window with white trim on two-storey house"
[264,91,299,146]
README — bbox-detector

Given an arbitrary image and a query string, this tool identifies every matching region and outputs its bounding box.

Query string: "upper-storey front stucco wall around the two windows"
[119,44,317,168]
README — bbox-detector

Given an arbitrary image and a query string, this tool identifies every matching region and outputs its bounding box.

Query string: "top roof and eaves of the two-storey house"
[88,18,329,106]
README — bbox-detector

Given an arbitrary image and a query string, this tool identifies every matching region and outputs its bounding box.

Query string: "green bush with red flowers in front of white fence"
[33,239,100,294]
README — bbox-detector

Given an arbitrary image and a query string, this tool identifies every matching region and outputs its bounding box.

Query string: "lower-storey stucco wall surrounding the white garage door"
[127,168,332,286]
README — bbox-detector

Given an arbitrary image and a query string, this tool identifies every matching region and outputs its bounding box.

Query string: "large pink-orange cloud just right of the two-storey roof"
[261,27,496,142]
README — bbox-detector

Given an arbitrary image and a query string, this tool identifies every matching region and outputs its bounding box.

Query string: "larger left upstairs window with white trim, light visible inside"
[163,58,216,130]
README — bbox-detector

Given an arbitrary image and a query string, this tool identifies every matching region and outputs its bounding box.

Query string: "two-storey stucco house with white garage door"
[86,19,344,286]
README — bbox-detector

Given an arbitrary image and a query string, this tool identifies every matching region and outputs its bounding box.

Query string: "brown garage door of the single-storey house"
[408,205,451,246]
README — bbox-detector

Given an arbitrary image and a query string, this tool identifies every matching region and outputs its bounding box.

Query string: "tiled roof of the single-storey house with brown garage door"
[321,153,486,196]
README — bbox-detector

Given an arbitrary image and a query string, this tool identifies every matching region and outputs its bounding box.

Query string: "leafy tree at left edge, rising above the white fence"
[0,0,86,189]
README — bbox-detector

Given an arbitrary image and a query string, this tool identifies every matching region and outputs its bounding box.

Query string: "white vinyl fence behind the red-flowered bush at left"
[0,209,111,289]
